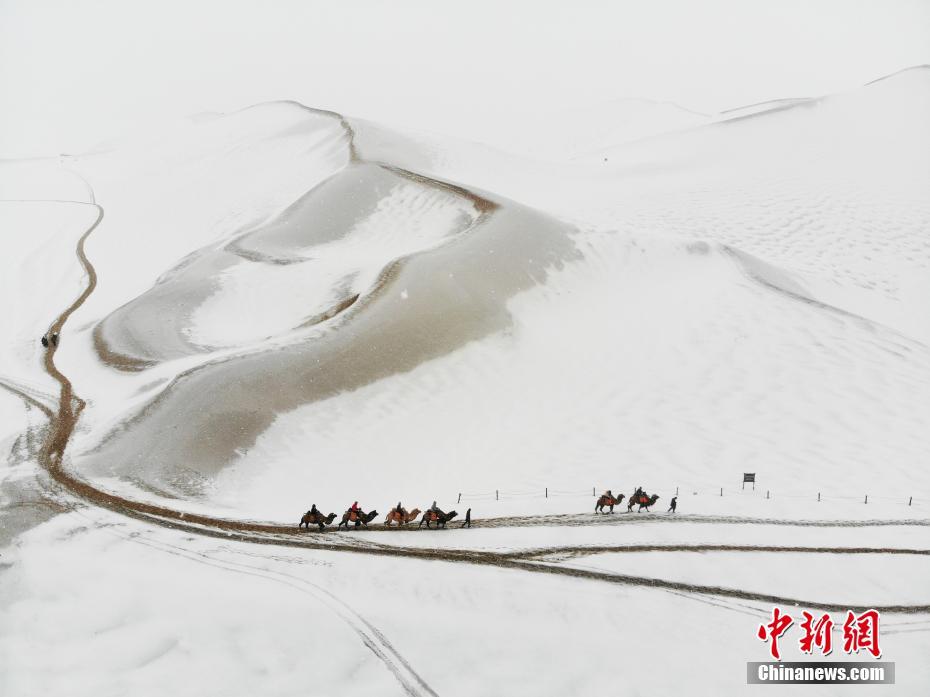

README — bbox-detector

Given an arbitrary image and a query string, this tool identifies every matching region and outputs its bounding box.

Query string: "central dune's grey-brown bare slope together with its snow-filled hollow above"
[82,137,578,484]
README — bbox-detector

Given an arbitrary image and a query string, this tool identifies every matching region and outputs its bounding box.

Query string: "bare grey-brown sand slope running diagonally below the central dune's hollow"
[78,189,577,486]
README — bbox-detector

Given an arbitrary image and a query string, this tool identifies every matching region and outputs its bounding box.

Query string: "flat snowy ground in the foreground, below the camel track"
[0,511,930,696]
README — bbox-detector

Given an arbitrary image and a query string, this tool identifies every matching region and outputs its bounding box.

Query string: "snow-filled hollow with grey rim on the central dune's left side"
[95,164,481,368]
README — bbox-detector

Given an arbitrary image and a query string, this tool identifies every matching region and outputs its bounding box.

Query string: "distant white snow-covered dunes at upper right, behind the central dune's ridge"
[355,66,930,343]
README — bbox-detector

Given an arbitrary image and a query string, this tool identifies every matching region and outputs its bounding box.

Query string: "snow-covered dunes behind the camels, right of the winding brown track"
[1,69,912,518]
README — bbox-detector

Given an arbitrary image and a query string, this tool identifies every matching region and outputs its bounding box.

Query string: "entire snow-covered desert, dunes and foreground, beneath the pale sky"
[0,62,930,695]
